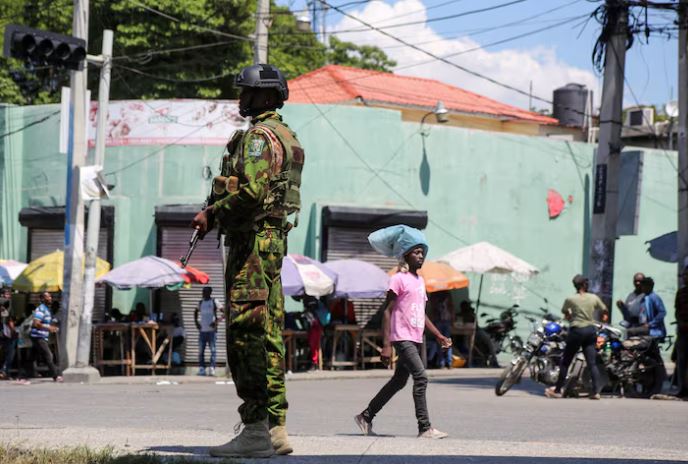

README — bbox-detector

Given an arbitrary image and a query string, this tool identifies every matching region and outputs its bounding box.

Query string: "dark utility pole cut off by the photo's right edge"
[669,0,688,280]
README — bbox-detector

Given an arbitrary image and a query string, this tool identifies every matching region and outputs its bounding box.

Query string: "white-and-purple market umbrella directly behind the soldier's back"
[281,254,337,298]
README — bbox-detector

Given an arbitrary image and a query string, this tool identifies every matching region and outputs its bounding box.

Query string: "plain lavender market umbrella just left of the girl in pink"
[324,259,389,298]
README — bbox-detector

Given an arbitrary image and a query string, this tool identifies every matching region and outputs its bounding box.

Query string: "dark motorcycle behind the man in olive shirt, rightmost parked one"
[564,324,671,398]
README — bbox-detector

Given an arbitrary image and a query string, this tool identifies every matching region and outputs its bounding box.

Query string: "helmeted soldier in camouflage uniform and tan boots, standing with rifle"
[192,65,304,457]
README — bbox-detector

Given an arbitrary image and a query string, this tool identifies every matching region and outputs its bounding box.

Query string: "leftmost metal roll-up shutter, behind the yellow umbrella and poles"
[29,227,108,322]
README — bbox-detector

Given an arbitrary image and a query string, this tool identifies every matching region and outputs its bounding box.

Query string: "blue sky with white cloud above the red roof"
[281,0,678,113]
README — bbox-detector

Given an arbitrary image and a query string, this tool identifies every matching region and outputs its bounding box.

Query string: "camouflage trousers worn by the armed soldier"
[225,227,288,427]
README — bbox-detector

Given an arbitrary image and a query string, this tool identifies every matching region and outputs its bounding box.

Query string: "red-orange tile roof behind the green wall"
[289,65,559,124]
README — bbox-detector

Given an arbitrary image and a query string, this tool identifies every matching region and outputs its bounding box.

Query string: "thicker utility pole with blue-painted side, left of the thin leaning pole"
[59,0,88,369]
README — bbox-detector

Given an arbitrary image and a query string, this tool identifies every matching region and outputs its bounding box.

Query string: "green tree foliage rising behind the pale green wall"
[0,0,396,105]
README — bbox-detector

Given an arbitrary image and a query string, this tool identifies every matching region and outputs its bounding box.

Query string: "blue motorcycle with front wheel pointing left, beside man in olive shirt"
[495,313,565,396]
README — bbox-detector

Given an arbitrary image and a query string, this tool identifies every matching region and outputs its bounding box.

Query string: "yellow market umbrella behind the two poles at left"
[12,250,110,293]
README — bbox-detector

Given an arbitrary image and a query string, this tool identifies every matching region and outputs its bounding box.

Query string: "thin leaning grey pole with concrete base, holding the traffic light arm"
[65,29,113,383]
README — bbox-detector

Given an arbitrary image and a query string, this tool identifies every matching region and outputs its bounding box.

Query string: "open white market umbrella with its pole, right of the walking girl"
[439,242,540,310]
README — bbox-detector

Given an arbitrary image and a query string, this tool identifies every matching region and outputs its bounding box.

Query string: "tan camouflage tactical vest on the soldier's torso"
[254,118,305,226]
